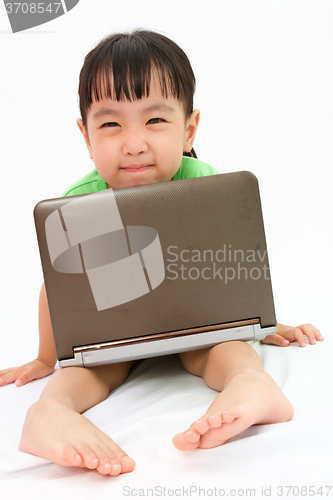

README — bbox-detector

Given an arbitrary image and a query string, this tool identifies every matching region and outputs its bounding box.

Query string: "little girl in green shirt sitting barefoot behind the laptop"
[0,31,322,476]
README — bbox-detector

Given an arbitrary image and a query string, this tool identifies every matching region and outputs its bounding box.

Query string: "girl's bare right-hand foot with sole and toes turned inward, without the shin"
[172,370,294,451]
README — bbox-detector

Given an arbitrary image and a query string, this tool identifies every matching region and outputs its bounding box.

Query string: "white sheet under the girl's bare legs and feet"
[0,332,333,500]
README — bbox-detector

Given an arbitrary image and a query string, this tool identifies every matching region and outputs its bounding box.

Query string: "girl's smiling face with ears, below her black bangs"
[77,74,200,188]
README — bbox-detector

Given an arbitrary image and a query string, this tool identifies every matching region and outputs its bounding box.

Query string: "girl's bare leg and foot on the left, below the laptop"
[19,362,135,475]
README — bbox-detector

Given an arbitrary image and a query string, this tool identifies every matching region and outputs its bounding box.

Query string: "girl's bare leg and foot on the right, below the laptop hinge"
[173,341,293,451]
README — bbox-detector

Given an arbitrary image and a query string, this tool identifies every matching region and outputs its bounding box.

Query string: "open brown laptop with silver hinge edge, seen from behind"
[34,171,276,367]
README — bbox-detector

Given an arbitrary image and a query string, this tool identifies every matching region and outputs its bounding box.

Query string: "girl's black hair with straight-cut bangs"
[79,30,196,157]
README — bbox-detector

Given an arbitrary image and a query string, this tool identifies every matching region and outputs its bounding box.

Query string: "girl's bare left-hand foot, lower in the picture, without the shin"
[19,398,135,476]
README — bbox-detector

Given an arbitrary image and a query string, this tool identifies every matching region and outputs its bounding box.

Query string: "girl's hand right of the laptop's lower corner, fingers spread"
[260,323,324,347]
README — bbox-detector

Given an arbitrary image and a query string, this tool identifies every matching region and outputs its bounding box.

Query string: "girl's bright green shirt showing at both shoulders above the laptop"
[63,156,218,196]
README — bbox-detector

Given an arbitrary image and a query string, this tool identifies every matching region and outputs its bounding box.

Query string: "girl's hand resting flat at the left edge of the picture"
[0,358,54,387]
